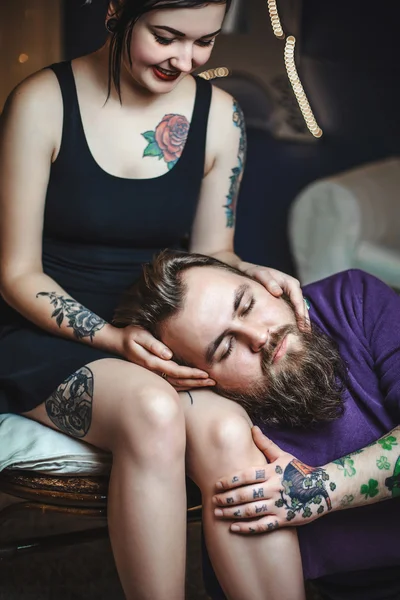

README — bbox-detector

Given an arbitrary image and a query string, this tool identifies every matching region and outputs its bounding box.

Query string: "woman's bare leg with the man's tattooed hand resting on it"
[181,390,305,600]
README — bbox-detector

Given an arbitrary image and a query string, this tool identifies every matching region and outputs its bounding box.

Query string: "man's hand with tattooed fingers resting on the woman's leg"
[214,427,336,534]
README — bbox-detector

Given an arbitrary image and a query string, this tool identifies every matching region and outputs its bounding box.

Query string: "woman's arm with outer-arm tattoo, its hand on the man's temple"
[190,87,308,319]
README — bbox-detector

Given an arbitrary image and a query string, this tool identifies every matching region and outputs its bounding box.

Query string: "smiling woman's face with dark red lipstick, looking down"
[120,3,226,94]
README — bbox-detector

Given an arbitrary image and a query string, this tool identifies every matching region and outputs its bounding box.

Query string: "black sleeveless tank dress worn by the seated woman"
[0,62,211,413]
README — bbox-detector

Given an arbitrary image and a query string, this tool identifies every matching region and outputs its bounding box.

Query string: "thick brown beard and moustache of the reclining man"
[214,325,347,427]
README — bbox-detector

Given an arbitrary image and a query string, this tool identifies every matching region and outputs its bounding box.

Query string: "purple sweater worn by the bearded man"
[263,270,400,579]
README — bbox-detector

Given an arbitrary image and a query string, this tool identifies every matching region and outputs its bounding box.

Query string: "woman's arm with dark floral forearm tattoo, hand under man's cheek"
[0,75,206,381]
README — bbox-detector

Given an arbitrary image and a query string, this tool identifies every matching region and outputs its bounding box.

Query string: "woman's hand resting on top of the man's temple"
[239,262,310,323]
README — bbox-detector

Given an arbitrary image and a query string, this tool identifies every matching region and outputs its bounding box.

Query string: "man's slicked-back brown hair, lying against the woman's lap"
[113,250,247,339]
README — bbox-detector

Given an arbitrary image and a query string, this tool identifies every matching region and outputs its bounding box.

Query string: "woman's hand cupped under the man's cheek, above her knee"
[119,325,215,391]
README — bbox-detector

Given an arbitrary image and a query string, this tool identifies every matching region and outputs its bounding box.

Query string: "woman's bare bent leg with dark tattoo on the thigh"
[25,359,186,600]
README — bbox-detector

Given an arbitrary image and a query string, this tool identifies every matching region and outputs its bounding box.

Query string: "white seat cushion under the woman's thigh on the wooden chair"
[0,414,112,475]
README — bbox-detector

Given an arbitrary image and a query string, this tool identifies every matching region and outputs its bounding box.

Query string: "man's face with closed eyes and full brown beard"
[162,267,345,426]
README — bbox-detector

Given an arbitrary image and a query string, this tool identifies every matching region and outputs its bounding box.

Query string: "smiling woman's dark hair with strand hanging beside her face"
[86,0,232,100]
